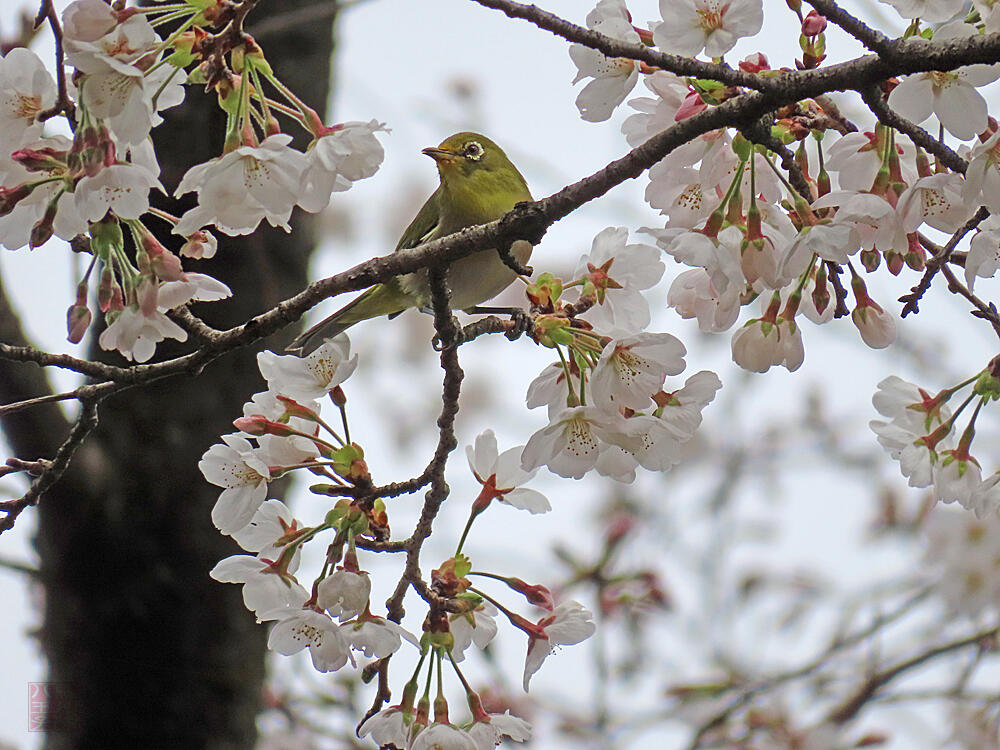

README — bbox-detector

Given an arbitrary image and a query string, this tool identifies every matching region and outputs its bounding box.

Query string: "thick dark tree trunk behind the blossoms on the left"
[0,0,335,750]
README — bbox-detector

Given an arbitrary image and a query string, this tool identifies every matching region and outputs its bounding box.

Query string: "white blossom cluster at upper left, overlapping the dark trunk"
[0,0,384,362]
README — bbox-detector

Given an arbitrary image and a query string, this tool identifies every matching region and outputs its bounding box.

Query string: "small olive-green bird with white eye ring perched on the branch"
[287,133,532,357]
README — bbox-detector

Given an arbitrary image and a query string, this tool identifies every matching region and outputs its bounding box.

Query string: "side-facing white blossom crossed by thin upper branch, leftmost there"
[569,0,639,122]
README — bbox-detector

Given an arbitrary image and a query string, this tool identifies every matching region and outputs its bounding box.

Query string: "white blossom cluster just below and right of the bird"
[521,227,722,482]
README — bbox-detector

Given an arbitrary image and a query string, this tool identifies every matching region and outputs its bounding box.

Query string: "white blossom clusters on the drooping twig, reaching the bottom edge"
[199,334,595,750]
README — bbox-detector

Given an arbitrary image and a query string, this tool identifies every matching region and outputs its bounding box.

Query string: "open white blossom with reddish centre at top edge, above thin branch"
[653,0,764,57]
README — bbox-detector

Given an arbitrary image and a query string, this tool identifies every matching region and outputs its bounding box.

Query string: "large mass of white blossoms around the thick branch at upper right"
[571,0,1000,372]
